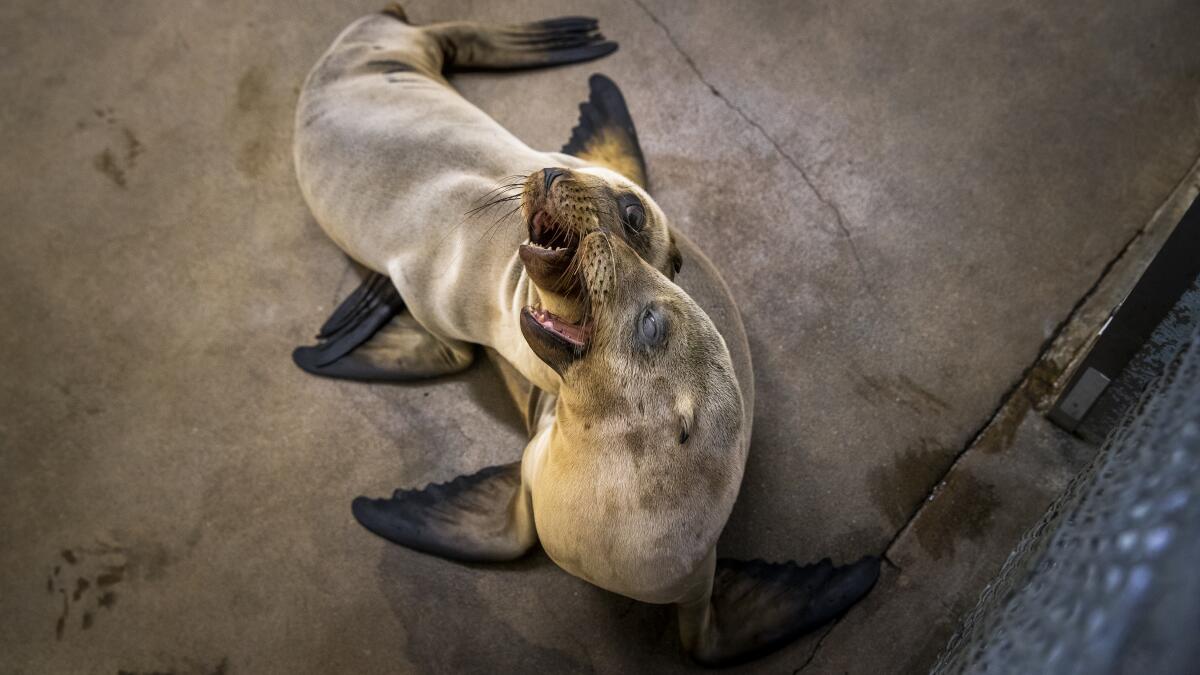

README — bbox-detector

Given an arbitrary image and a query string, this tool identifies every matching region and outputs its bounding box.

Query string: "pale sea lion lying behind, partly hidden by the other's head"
[294,11,677,392]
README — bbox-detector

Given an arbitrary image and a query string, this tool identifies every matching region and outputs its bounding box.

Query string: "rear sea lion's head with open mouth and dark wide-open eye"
[520,167,683,318]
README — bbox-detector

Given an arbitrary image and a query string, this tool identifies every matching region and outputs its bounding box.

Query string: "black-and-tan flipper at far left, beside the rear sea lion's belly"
[292,273,474,382]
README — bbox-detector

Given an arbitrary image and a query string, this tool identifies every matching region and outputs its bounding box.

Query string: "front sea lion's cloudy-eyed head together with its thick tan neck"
[521,231,745,593]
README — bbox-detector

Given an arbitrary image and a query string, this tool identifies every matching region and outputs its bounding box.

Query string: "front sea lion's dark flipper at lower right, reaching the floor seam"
[679,556,880,667]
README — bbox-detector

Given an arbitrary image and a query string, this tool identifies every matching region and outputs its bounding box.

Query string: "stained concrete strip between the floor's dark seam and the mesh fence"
[805,154,1200,674]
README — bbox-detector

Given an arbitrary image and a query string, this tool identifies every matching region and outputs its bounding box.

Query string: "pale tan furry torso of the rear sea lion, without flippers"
[294,14,670,392]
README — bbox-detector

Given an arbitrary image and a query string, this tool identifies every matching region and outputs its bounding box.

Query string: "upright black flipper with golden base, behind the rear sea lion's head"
[562,73,649,190]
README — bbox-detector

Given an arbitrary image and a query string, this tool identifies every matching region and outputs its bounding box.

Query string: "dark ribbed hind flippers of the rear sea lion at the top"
[383,4,617,72]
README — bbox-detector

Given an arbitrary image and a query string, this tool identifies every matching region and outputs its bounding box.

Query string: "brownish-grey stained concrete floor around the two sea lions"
[0,0,1200,674]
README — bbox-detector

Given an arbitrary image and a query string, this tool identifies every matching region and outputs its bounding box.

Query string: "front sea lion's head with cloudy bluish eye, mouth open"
[521,225,743,473]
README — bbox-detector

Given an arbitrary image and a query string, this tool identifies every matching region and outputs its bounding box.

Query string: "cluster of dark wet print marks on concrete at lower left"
[46,545,128,640]
